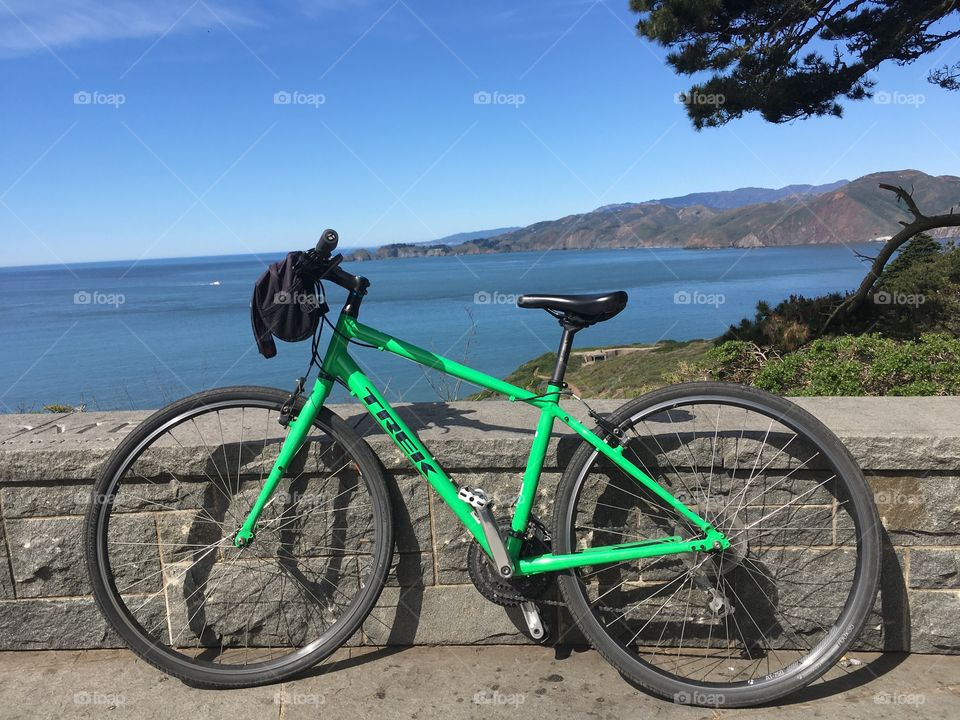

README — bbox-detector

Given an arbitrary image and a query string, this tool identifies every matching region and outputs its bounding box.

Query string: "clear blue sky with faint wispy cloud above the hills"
[0,0,960,265]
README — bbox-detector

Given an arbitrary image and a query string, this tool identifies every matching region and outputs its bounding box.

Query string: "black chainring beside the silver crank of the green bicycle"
[467,516,553,607]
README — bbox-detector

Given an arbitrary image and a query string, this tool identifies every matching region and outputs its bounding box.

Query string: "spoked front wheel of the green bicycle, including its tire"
[86,387,393,688]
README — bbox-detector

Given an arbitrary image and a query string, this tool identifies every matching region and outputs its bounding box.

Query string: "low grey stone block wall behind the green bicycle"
[0,398,960,653]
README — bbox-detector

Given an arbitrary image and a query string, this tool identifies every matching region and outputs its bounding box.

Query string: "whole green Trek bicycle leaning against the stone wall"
[85,231,880,707]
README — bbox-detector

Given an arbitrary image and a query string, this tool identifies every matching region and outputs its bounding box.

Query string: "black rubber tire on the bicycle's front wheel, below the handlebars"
[85,386,393,688]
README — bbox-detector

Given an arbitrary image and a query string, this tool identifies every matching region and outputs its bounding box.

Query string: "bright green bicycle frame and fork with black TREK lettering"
[234,313,730,576]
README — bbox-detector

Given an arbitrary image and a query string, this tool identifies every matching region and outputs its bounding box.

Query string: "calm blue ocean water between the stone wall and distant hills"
[0,246,866,412]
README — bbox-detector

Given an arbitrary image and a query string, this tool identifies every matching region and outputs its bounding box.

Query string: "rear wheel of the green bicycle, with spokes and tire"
[553,383,880,707]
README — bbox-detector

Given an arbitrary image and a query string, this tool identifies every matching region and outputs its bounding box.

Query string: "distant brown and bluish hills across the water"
[352,170,960,260]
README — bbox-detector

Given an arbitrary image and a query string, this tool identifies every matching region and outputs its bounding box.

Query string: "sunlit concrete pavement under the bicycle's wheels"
[0,646,960,720]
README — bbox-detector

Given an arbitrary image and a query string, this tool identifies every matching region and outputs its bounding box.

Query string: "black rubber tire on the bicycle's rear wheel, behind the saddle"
[553,382,880,707]
